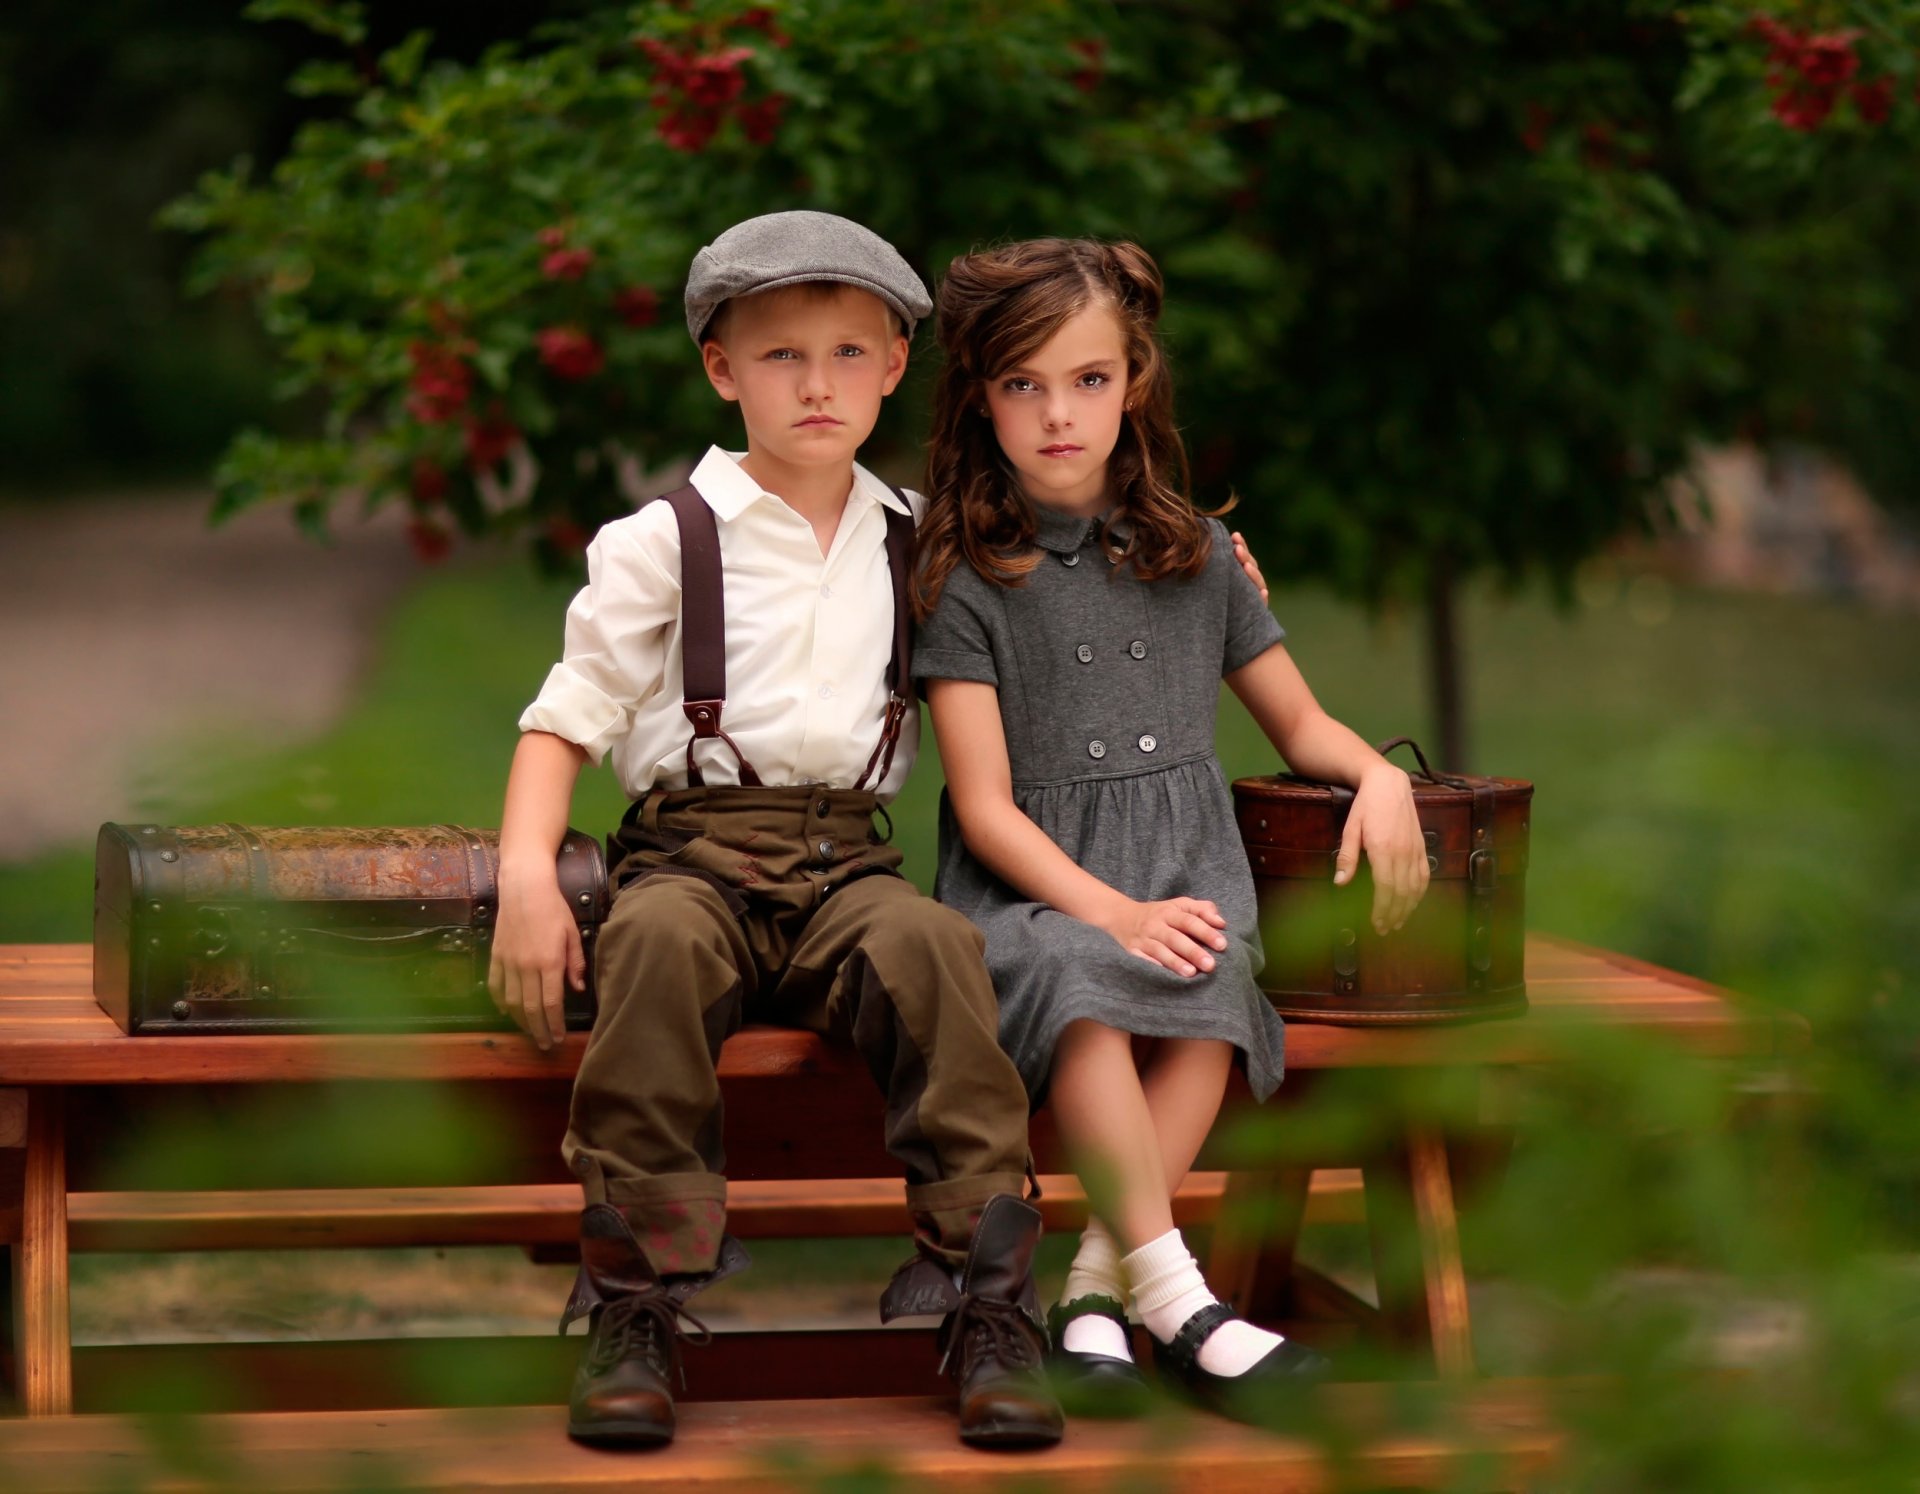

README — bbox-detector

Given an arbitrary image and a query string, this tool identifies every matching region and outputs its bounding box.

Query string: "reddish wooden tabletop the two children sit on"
[0,935,1807,1085]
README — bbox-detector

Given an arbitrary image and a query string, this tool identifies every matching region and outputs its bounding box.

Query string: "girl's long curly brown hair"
[914,238,1233,618]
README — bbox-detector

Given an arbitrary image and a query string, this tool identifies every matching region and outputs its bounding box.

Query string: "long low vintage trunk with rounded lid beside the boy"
[94,824,609,1035]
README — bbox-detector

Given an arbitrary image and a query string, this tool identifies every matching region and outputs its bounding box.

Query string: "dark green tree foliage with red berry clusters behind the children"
[169,0,1920,601]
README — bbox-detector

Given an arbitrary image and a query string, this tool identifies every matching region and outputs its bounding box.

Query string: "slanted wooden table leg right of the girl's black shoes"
[1365,1125,1475,1379]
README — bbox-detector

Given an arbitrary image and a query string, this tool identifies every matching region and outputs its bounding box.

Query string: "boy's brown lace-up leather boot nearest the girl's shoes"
[939,1193,1064,1448]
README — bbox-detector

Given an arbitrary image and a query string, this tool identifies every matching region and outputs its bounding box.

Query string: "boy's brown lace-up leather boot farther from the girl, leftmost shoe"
[561,1204,747,1448]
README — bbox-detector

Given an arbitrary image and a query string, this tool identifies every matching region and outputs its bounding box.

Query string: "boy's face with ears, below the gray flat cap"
[701,286,906,467]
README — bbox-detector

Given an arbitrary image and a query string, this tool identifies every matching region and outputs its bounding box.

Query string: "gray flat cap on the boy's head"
[687,211,933,342]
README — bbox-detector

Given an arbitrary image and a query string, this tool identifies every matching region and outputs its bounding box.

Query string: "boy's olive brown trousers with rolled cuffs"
[564,785,1029,1275]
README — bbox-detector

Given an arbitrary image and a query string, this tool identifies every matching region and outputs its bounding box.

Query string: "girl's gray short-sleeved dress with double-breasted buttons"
[914,509,1284,1106]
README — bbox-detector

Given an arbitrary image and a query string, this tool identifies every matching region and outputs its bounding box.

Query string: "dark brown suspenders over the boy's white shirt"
[659,484,914,789]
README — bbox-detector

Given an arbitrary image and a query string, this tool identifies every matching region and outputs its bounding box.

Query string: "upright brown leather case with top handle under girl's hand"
[1233,737,1534,1025]
